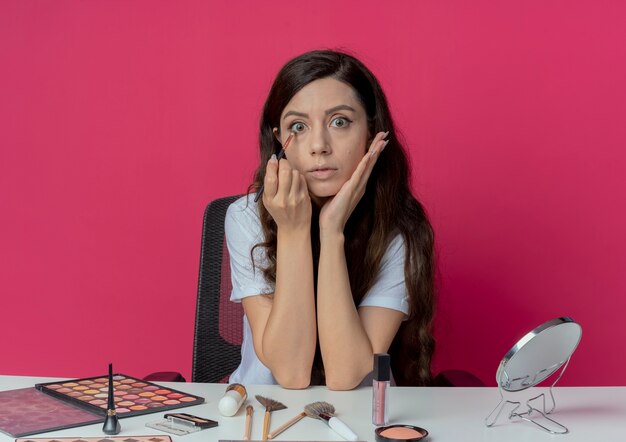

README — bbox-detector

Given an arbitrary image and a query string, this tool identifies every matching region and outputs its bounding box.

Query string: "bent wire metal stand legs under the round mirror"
[485,358,570,434]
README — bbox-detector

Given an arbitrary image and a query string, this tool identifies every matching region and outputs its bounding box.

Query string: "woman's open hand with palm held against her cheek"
[320,132,389,233]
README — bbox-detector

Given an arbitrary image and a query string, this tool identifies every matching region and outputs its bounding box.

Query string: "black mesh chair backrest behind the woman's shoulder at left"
[191,195,243,382]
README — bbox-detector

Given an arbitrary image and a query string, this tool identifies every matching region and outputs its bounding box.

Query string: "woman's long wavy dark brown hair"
[249,50,435,385]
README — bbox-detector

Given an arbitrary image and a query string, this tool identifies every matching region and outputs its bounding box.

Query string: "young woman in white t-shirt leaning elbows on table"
[225,51,434,390]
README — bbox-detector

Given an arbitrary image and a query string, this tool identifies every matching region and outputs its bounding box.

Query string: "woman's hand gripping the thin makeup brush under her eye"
[263,155,311,229]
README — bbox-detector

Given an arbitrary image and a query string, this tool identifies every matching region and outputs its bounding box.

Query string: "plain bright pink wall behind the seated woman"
[0,0,626,385]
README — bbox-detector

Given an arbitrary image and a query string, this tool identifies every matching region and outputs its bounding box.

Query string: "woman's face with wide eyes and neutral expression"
[279,78,369,203]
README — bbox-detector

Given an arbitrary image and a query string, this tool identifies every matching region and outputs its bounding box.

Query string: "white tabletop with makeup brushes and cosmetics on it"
[0,376,626,442]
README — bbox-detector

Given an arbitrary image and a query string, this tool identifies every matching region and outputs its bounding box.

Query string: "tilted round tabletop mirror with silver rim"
[496,317,582,391]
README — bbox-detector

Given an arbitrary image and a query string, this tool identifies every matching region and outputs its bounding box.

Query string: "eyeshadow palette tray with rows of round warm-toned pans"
[35,374,204,418]
